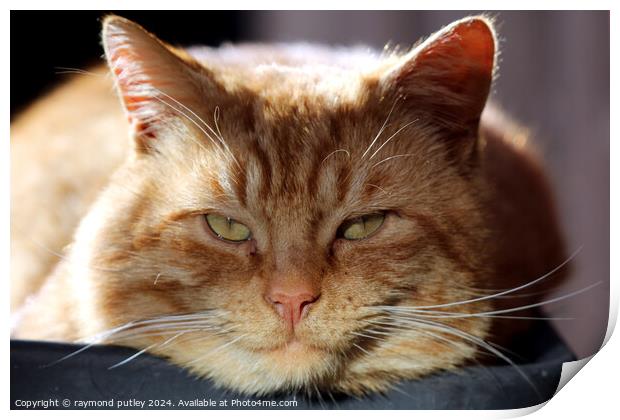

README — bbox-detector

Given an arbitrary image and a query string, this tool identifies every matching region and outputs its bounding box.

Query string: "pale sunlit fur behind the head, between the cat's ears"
[188,43,395,103]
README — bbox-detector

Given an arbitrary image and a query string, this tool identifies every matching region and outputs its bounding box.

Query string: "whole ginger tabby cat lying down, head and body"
[11,18,564,394]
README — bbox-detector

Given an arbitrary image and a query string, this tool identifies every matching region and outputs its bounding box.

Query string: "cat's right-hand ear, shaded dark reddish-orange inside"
[381,17,496,131]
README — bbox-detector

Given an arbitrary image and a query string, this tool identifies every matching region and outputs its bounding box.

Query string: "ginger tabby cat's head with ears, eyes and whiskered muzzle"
[78,18,494,393]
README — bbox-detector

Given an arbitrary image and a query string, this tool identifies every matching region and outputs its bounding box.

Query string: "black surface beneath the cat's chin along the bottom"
[11,324,574,409]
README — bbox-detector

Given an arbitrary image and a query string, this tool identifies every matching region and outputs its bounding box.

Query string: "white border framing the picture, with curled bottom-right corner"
[0,0,620,420]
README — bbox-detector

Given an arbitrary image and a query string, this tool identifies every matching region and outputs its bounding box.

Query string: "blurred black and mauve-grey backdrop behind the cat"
[10,11,610,357]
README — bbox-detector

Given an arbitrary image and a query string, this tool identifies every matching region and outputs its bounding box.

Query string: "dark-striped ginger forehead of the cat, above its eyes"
[185,106,426,226]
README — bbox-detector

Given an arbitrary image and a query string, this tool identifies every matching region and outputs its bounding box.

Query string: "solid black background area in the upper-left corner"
[11,10,244,116]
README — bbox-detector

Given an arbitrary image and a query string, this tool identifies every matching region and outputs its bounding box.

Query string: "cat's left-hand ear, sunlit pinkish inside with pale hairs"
[102,16,204,151]
